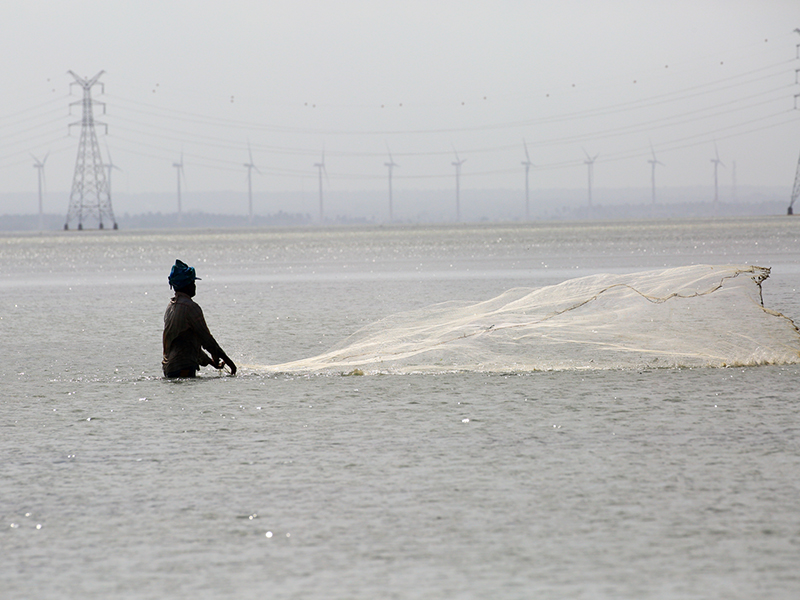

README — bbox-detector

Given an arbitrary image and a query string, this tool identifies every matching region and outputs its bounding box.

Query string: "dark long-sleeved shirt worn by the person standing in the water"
[161,292,225,375]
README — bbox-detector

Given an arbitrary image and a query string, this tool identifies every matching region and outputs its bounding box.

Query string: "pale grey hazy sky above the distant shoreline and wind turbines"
[0,0,800,203]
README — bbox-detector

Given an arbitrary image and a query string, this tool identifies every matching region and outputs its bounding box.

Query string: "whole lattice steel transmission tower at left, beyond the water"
[64,71,118,229]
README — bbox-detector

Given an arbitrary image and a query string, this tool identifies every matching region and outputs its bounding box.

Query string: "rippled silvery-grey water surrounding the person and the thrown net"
[0,217,800,599]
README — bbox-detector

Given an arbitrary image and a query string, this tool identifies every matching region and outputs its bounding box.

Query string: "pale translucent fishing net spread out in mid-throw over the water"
[264,265,800,373]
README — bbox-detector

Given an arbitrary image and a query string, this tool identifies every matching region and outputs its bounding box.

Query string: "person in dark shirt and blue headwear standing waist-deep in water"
[161,260,236,378]
